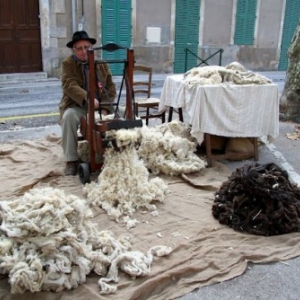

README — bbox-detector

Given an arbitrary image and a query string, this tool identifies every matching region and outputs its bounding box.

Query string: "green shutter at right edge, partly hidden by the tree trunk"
[278,0,300,71]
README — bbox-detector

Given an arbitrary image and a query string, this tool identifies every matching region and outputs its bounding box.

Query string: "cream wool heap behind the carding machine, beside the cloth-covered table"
[78,120,206,176]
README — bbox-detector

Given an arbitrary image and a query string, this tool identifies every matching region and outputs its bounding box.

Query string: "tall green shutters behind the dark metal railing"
[174,0,201,73]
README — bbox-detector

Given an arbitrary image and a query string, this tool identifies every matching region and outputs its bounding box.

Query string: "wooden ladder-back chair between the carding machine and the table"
[133,65,166,125]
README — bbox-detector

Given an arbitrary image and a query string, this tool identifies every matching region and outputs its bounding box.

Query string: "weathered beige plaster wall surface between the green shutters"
[39,0,285,77]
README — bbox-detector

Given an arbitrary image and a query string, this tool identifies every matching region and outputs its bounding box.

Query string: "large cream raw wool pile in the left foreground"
[0,187,172,294]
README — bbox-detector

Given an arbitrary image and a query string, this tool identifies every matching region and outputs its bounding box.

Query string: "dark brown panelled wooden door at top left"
[0,0,42,74]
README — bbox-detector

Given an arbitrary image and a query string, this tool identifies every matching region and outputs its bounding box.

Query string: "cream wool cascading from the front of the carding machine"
[83,129,168,225]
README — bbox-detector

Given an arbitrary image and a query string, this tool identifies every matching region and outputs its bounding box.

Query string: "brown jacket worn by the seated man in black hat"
[59,55,116,118]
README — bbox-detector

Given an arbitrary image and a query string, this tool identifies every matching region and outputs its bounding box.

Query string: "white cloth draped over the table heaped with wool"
[159,74,279,144]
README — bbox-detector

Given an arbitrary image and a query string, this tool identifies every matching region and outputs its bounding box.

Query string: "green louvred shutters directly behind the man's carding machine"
[102,0,131,75]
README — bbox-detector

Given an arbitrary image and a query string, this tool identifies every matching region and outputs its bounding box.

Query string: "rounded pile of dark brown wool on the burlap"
[212,163,300,236]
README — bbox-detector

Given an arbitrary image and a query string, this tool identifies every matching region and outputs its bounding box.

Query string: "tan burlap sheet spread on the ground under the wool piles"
[0,137,300,300]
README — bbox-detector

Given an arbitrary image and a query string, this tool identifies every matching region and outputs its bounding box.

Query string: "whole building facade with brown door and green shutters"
[0,0,300,77]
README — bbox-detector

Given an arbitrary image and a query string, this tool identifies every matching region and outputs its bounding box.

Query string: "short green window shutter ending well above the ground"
[234,0,257,45]
